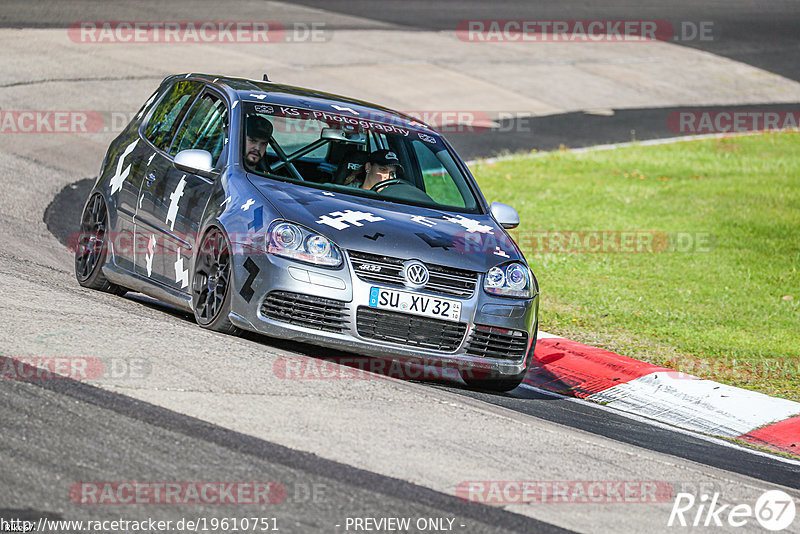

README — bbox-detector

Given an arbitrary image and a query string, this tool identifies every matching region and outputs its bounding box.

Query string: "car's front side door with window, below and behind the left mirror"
[138,89,228,292]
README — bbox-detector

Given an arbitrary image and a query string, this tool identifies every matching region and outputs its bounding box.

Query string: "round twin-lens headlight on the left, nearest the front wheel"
[267,221,342,267]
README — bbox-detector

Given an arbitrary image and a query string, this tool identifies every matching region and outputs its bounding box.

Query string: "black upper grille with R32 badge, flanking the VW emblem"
[349,250,478,298]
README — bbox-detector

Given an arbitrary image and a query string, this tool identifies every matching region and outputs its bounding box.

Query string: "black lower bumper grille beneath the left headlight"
[261,291,348,332]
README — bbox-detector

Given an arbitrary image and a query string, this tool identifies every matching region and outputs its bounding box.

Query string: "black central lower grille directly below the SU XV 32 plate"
[356,306,467,352]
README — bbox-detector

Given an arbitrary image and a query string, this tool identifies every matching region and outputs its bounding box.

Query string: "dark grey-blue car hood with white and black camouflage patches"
[248,174,523,272]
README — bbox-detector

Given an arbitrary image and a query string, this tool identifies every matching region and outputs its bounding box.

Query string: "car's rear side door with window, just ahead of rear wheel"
[133,80,203,283]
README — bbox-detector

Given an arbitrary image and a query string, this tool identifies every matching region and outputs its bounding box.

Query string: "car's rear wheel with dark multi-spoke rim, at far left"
[75,193,128,295]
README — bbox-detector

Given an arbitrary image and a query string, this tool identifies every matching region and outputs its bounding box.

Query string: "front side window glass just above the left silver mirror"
[169,93,228,162]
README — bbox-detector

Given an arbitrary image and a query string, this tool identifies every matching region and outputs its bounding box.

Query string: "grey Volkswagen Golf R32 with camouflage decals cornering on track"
[75,74,539,391]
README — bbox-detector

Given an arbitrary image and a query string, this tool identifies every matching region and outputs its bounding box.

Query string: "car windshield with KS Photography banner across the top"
[242,102,479,213]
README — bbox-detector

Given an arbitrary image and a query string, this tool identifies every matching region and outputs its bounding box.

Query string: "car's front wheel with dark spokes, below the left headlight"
[192,228,239,334]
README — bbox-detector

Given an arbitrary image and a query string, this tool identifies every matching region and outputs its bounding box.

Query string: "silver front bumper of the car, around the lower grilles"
[231,249,538,377]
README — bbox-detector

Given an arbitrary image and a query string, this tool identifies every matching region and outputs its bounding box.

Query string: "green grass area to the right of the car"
[473,133,800,400]
